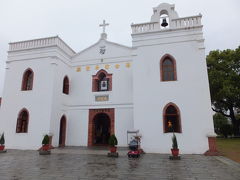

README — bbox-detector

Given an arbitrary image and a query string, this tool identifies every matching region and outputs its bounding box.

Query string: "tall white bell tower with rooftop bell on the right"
[131,3,214,154]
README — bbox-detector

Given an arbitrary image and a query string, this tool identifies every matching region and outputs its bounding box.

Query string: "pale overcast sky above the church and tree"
[0,0,240,96]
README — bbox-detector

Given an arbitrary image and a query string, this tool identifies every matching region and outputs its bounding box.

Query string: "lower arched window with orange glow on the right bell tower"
[163,103,182,133]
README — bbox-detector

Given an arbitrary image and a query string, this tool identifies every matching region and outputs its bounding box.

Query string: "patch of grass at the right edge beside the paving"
[217,138,240,163]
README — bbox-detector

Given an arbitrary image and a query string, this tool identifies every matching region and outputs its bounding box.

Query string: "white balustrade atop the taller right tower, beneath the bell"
[131,14,202,34]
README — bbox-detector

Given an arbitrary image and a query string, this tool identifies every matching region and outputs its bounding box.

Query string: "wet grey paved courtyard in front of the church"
[0,148,240,180]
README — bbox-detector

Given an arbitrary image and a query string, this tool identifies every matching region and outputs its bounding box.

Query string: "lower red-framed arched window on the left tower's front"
[16,108,29,133]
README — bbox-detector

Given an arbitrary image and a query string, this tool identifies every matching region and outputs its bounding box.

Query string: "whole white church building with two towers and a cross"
[0,3,214,154]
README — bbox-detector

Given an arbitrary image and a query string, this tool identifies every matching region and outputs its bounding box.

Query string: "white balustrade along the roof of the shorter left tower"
[9,36,75,56]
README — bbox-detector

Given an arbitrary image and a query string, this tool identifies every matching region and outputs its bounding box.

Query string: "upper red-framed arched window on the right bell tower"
[160,54,177,81]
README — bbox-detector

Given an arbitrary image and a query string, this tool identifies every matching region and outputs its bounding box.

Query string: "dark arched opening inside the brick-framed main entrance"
[92,113,111,145]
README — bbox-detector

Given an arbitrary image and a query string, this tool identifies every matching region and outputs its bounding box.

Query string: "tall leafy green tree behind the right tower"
[207,46,240,135]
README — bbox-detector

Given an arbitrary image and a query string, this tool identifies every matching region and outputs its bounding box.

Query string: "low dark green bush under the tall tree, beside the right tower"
[213,113,233,138]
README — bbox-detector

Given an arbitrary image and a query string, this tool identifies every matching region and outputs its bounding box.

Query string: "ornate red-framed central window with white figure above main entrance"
[92,69,112,92]
